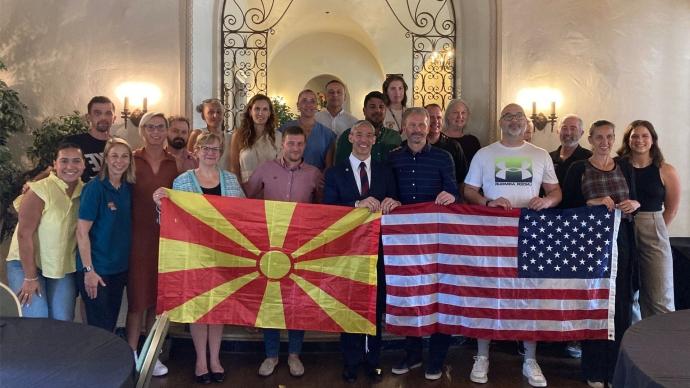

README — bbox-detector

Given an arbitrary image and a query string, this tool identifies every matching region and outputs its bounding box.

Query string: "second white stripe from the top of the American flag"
[383,233,518,247]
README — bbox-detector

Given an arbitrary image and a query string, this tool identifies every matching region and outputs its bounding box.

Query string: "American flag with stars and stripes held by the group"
[382,203,620,341]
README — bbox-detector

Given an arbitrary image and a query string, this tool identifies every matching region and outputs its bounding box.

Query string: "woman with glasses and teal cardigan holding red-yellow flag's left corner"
[153,133,244,384]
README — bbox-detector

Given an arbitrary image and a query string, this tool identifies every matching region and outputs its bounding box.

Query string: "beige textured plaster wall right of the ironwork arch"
[499,0,690,236]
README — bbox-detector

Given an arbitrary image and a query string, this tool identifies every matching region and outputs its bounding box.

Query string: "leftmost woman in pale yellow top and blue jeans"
[7,143,84,321]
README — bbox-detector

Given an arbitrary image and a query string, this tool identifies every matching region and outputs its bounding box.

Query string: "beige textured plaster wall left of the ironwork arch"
[0,0,185,151]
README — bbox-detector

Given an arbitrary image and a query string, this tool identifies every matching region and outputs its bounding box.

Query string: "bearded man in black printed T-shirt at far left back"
[66,96,116,182]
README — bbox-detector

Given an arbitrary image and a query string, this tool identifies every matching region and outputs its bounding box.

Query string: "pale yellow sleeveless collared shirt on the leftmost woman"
[7,172,84,279]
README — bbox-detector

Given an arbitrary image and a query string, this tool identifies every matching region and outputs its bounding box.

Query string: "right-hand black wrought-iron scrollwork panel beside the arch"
[386,0,456,107]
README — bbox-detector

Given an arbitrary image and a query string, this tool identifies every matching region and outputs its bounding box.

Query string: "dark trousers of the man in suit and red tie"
[340,249,386,370]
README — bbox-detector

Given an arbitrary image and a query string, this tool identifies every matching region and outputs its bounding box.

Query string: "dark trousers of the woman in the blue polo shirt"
[77,271,127,332]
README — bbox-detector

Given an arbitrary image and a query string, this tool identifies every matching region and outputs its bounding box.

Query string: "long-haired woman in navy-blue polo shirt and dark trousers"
[77,137,134,331]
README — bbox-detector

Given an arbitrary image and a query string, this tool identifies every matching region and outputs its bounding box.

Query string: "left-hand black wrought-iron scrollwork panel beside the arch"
[220,0,293,130]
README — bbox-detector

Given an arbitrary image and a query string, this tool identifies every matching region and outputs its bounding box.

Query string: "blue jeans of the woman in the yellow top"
[7,260,77,321]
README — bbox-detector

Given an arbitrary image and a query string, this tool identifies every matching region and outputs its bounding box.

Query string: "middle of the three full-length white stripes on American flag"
[386,293,608,310]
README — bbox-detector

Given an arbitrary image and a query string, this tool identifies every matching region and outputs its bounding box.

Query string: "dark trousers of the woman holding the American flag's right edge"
[581,220,635,382]
